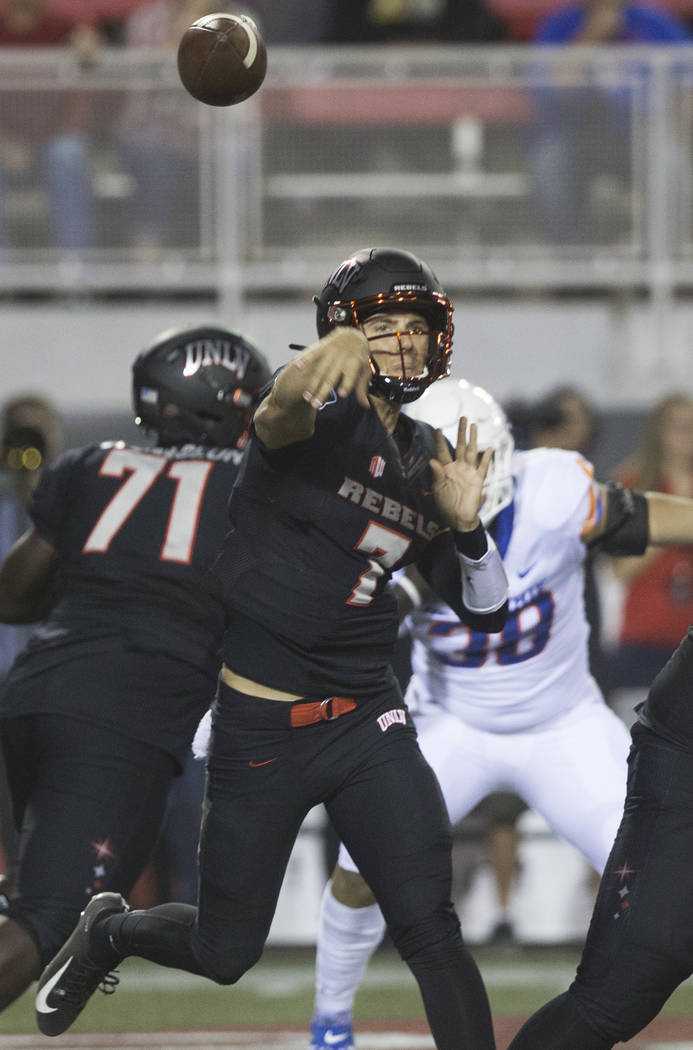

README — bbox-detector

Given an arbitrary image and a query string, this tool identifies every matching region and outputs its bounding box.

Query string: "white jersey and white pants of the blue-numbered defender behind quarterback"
[401,448,630,872]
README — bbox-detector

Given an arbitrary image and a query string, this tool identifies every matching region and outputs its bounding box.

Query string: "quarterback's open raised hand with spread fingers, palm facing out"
[431,416,494,532]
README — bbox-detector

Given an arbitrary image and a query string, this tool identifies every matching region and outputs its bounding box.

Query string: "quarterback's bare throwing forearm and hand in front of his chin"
[253,328,372,448]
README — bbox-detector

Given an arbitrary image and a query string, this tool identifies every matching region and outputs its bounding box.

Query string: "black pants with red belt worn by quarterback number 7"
[110,681,495,1050]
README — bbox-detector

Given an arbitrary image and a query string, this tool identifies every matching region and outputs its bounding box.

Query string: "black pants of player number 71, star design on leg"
[0,714,176,965]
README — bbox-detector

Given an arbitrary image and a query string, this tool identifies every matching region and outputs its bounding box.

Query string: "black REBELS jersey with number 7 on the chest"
[216,396,459,696]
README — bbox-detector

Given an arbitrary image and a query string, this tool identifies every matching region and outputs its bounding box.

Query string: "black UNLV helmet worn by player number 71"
[132,324,271,448]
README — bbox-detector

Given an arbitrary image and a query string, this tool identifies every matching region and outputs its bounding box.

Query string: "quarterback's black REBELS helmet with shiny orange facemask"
[313,248,454,404]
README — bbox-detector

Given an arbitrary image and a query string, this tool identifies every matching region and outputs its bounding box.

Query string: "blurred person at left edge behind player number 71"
[0,392,63,891]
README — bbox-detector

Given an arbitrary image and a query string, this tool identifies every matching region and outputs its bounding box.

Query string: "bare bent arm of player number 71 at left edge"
[0,528,58,624]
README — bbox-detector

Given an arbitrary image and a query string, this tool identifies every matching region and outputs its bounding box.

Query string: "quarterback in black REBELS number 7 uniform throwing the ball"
[37,249,507,1050]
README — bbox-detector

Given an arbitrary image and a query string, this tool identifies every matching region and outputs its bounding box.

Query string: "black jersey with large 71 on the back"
[0,442,242,749]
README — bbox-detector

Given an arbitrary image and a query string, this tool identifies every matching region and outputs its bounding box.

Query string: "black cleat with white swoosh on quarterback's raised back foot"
[36,894,129,1035]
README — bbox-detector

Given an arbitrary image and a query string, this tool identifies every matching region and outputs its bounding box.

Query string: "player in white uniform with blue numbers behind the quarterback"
[311,379,688,1050]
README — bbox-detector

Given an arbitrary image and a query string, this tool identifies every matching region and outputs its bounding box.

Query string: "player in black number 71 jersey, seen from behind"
[0,326,270,1008]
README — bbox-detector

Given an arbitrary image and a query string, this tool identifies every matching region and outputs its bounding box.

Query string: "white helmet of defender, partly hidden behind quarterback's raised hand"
[404,379,515,526]
